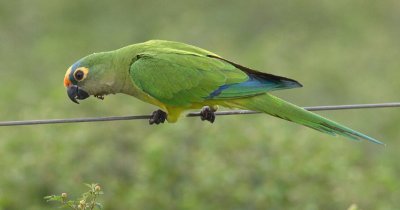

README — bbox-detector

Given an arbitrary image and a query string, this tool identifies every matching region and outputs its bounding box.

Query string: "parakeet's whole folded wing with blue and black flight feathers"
[130,41,301,106]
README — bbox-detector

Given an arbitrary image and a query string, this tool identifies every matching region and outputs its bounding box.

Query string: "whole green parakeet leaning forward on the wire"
[64,40,382,144]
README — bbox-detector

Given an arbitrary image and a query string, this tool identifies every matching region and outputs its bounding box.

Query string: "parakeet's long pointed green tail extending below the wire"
[231,93,383,144]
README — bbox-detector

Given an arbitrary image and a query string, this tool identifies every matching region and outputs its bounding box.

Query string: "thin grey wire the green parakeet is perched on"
[0,102,400,126]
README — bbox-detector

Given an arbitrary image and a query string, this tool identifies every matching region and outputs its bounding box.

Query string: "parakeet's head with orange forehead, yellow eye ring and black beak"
[64,53,115,104]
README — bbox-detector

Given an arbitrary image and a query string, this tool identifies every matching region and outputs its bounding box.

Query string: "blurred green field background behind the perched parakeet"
[0,0,400,210]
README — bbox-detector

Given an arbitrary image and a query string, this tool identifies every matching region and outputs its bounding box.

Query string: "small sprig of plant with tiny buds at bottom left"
[44,184,103,210]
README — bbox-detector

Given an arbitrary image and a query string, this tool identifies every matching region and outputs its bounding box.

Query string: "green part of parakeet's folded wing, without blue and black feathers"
[130,52,249,106]
